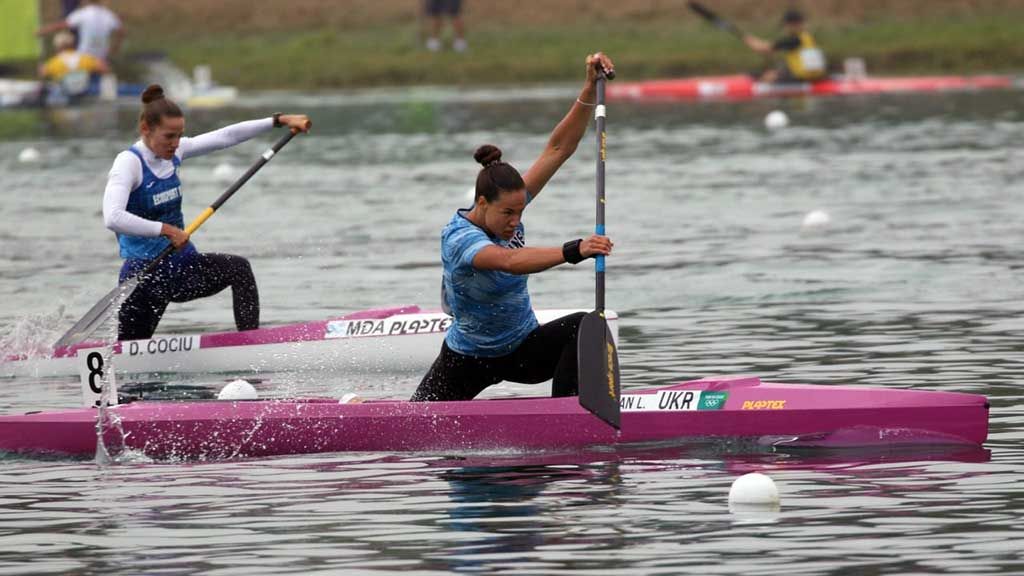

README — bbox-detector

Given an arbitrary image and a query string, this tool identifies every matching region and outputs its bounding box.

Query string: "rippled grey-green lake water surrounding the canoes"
[0,87,1024,574]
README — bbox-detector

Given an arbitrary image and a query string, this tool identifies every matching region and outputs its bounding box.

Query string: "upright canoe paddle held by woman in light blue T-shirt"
[577,65,621,429]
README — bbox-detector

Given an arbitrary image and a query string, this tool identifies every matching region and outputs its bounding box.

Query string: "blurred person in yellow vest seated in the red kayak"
[743,9,828,82]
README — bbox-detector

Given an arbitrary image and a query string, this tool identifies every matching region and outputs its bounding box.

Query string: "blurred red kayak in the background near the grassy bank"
[607,75,1015,100]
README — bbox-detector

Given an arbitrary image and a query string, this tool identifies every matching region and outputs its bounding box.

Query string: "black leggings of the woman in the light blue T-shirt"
[411,312,586,402]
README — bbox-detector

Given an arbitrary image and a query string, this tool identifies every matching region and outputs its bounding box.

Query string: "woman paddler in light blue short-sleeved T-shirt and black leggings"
[412,53,612,402]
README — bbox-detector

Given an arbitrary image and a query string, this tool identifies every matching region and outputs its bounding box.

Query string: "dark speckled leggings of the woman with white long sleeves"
[118,253,259,340]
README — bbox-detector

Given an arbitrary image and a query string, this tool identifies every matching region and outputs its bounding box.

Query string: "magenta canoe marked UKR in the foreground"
[0,377,988,459]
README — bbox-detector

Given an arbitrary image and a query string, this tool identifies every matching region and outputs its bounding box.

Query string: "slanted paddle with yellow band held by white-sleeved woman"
[53,124,307,348]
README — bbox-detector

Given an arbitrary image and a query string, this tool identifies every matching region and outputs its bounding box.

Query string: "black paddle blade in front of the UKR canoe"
[577,311,622,429]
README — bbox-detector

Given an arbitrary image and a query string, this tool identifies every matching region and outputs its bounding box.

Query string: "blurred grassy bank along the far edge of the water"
[39,0,1024,89]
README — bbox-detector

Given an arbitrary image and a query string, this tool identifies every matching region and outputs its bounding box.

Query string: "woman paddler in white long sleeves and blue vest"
[103,84,309,340]
